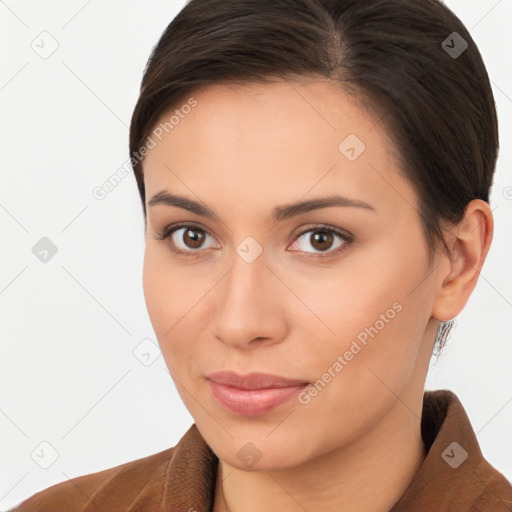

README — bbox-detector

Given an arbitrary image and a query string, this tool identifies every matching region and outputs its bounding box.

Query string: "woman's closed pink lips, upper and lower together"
[207,372,309,416]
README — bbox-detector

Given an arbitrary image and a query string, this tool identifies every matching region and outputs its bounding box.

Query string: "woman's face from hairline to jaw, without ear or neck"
[143,81,439,469]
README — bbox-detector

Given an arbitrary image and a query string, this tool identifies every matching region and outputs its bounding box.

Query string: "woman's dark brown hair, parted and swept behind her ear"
[130,0,499,348]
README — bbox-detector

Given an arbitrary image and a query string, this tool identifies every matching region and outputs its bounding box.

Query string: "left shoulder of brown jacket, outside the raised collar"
[9,447,176,512]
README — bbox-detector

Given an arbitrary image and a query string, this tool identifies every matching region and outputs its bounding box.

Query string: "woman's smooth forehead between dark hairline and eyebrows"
[143,80,408,214]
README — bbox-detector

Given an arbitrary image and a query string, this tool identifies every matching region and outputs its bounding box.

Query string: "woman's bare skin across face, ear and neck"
[143,80,493,512]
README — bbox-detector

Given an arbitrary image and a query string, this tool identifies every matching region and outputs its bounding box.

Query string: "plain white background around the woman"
[0,0,512,510]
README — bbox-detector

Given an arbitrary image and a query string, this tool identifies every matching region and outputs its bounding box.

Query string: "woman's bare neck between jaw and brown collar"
[214,397,425,512]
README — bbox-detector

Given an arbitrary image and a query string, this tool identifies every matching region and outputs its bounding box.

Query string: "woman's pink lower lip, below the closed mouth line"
[208,380,309,416]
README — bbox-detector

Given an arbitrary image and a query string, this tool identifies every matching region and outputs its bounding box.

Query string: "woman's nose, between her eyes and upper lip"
[210,247,290,348]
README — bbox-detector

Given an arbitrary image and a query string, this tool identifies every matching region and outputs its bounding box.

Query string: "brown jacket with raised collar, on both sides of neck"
[8,390,512,512]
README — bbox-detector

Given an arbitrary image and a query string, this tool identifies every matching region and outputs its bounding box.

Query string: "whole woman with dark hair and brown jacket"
[10,0,512,512]
